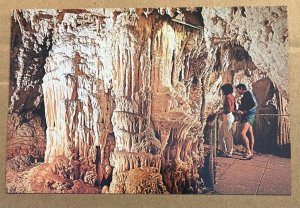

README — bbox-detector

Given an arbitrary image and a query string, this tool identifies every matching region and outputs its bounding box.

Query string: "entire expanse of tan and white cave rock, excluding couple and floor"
[8,7,290,194]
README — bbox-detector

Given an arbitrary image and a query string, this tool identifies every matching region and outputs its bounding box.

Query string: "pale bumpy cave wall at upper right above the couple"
[202,7,288,95]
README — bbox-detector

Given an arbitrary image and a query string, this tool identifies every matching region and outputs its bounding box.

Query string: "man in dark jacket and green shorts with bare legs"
[236,84,257,160]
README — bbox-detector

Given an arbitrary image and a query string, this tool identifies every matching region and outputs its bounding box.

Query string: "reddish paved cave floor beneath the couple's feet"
[215,154,291,195]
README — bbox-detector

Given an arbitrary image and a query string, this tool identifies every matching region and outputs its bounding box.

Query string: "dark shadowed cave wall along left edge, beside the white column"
[7,11,52,161]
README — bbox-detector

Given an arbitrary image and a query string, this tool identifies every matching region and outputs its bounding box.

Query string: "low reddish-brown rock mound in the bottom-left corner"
[6,156,99,193]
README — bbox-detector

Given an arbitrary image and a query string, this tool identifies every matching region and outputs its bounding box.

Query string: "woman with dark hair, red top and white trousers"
[218,83,235,157]
